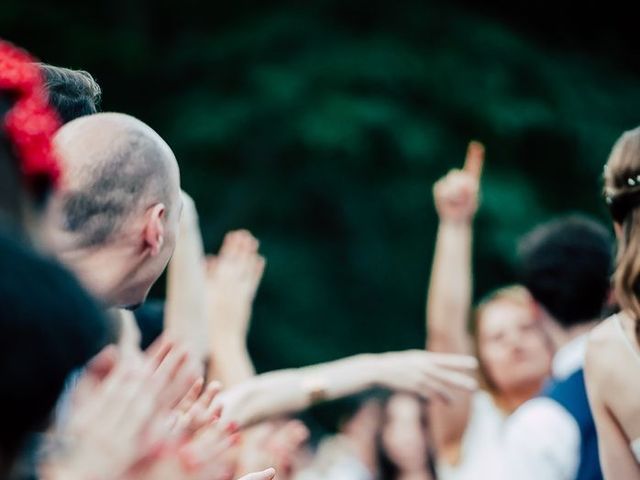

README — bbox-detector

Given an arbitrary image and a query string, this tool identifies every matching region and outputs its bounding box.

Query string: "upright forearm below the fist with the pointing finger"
[426,221,472,353]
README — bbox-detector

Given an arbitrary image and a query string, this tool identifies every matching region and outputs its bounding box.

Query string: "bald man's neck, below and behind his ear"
[58,245,140,307]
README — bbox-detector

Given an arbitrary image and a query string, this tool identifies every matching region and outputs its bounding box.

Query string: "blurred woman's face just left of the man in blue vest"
[478,300,552,394]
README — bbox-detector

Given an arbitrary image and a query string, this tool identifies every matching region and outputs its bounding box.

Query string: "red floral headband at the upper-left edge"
[0,40,61,193]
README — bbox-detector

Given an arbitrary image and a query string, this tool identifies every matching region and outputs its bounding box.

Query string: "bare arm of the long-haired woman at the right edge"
[585,337,640,480]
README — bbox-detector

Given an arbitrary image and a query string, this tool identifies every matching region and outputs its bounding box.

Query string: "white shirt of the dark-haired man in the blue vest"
[494,334,587,480]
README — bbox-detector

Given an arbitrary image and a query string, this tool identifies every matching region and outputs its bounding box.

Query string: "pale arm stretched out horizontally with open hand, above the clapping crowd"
[219,350,477,427]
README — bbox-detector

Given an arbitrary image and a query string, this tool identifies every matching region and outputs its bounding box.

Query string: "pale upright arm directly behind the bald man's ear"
[164,192,208,360]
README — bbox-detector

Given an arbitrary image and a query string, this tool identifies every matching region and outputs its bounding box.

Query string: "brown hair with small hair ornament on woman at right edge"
[604,127,640,343]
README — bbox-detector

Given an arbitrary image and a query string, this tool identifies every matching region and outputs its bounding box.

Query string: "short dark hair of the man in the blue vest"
[519,214,613,328]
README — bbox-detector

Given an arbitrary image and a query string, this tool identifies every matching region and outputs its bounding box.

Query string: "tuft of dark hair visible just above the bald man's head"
[39,63,102,123]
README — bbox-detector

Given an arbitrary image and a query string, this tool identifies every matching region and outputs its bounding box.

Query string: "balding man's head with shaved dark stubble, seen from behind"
[50,113,181,305]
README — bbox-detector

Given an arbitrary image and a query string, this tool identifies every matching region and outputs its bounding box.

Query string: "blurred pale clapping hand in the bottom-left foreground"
[44,349,170,479]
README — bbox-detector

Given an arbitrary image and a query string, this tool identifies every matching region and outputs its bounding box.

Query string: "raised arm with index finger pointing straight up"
[426,142,484,463]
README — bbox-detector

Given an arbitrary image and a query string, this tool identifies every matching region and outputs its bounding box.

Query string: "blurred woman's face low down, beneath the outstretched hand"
[382,393,429,471]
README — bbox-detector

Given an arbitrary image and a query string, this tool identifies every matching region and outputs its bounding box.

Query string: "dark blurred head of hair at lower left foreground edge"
[0,232,108,474]
